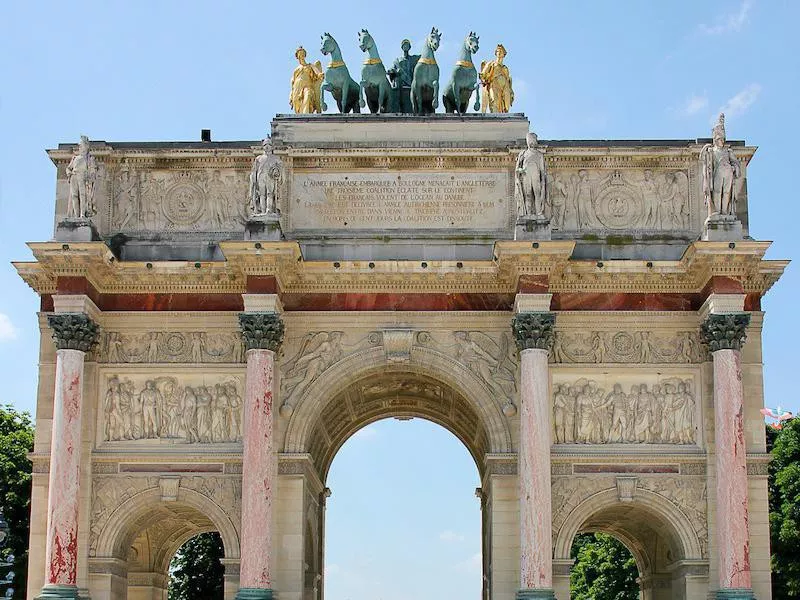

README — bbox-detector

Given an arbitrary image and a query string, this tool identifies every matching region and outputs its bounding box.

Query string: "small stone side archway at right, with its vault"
[553,488,708,600]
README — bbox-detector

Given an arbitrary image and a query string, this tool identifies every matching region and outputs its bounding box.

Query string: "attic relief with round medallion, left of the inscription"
[108,169,248,232]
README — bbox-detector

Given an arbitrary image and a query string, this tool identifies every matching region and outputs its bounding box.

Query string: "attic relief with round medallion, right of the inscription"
[547,169,692,232]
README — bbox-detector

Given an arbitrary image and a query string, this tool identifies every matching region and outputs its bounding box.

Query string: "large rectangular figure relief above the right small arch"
[552,375,698,445]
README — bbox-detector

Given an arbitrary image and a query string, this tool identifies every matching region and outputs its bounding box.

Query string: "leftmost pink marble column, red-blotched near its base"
[38,313,98,599]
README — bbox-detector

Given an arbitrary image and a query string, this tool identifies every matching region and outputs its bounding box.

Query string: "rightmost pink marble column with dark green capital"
[702,313,755,599]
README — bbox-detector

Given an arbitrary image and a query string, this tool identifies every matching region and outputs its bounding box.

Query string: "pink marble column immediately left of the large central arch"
[236,312,283,600]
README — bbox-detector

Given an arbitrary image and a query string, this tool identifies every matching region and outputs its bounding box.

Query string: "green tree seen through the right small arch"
[569,533,639,600]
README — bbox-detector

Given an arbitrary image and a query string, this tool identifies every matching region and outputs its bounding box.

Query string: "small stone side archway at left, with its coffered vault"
[90,487,239,600]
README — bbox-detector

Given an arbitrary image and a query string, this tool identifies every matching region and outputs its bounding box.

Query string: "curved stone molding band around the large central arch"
[284,346,511,460]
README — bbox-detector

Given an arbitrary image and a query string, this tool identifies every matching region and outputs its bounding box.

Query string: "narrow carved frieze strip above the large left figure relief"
[97,331,244,363]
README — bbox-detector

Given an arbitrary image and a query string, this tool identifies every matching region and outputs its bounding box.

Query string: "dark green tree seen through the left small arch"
[169,532,225,600]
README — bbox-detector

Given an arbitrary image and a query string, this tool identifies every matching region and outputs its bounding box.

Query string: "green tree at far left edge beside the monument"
[0,406,33,598]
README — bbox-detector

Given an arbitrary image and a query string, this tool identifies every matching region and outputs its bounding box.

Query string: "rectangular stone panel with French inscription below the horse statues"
[289,171,513,231]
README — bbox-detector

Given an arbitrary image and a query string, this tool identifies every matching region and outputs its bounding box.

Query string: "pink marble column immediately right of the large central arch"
[512,312,555,600]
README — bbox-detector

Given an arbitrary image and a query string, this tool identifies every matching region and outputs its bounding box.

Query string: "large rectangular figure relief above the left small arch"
[100,374,244,444]
